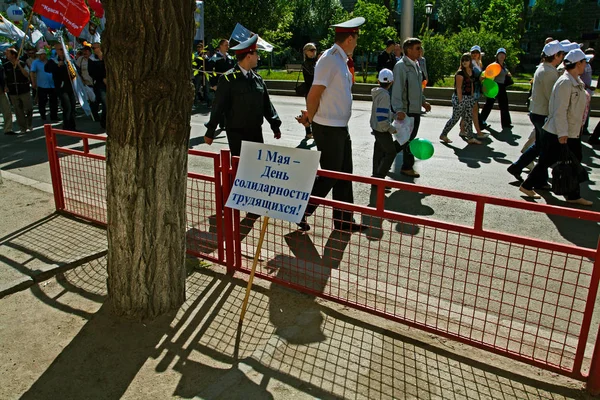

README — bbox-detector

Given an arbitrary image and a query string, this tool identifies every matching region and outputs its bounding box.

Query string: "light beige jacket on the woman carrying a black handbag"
[544,72,586,138]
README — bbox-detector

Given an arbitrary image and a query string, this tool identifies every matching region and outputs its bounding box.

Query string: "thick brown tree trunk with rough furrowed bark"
[102,0,195,319]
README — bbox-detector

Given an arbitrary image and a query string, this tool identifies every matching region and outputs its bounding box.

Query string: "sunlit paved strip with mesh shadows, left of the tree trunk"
[0,171,107,297]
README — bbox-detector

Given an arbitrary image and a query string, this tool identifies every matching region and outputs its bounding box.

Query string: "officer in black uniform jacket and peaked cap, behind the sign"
[204,35,281,156]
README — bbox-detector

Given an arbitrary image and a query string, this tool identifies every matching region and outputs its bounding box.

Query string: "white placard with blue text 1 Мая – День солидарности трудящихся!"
[226,142,321,222]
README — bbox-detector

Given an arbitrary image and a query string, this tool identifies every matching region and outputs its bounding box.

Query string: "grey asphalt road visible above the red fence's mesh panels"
[0,96,600,247]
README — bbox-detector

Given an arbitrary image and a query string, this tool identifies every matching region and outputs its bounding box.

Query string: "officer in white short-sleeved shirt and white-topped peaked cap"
[296,17,365,232]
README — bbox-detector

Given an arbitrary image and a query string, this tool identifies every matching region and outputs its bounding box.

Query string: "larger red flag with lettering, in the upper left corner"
[33,0,90,36]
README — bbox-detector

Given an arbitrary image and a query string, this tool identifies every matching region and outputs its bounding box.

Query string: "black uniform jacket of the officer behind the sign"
[206,65,281,138]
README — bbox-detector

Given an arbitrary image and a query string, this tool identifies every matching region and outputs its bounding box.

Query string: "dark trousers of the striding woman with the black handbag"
[522,131,581,200]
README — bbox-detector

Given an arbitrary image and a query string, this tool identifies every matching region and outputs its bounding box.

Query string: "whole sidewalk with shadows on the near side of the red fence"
[0,176,586,400]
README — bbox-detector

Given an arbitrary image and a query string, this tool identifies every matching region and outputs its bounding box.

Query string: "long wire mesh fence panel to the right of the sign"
[240,206,594,375]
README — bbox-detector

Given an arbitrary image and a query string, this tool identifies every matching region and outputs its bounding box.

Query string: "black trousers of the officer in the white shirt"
[305,122,354,223]
